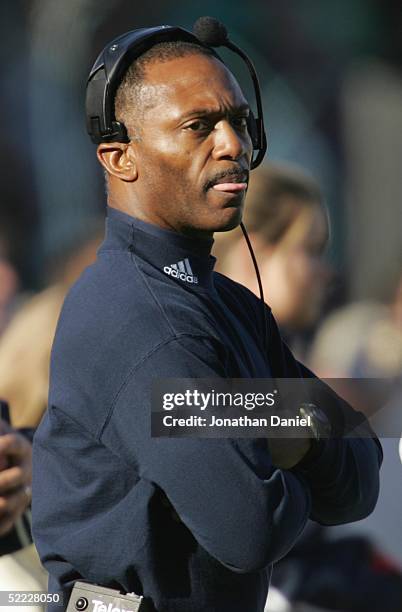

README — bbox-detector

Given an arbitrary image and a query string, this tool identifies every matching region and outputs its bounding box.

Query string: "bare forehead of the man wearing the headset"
[137,54,247,118]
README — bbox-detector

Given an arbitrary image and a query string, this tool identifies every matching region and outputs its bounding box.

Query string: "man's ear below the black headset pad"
[96,142,138,182]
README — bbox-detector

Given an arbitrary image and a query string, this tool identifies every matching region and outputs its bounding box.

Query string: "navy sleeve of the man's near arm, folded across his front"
[101,336,311,572]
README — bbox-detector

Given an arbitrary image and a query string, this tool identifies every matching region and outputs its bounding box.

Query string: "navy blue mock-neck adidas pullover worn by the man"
[33,209,380,612]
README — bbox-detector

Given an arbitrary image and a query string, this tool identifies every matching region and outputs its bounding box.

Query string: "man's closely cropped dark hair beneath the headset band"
[114,40,216,140]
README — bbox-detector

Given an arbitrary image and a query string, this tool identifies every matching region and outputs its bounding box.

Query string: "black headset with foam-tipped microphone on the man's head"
[86,17,267,169]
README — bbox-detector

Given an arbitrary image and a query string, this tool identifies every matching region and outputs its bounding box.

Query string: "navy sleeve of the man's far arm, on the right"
[269,314,382,525]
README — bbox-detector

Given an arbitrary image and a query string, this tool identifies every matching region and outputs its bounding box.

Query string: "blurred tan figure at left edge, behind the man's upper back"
[0,223,103,427]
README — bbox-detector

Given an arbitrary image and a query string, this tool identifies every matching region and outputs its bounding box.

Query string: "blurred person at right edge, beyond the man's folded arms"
[308,270,402,572]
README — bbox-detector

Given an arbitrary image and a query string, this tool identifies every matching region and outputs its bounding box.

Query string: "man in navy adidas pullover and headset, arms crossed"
[33,17,381,612]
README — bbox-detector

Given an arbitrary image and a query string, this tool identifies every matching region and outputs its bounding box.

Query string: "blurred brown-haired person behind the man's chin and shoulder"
[214,164,331,348]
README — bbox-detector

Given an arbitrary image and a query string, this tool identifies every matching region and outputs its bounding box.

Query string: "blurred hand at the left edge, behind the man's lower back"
[0,420,32,536]
